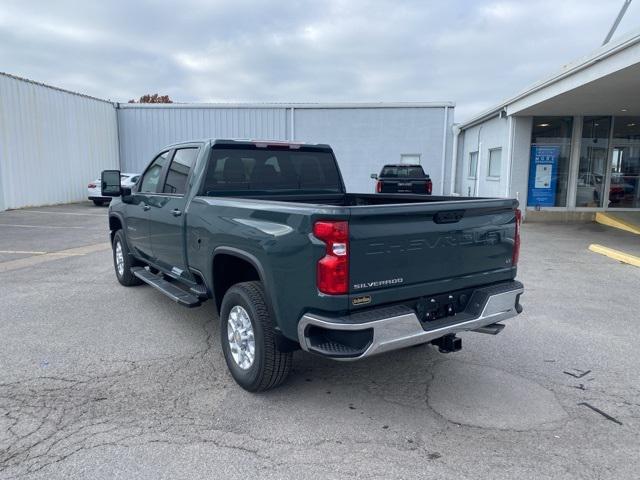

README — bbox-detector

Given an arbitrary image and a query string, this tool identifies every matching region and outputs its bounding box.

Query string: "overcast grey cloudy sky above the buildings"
[0,0,640,121]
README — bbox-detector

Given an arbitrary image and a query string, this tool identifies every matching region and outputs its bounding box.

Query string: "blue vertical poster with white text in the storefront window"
[527,145,560,207]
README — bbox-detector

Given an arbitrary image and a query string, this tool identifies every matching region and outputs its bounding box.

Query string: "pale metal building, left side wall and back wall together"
[0,73,454,210]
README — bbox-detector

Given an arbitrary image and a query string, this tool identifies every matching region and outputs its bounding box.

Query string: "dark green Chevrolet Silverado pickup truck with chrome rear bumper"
[102,140,523,391]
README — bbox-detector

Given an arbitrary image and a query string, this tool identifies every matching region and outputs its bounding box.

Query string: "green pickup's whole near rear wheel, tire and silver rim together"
[220,282,292,392]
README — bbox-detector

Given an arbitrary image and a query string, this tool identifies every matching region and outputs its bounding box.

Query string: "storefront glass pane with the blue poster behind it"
[527,117,573,207]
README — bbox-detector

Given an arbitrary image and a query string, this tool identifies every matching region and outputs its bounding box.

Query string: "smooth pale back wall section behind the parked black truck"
[295,107,454,193]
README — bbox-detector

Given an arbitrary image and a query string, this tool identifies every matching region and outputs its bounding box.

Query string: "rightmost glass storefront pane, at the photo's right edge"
[608,117,640,208]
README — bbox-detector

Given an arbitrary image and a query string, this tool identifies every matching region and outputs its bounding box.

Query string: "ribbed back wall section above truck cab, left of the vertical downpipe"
[117,104,290,173]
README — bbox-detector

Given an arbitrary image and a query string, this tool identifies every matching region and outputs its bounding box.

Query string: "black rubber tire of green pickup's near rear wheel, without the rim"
[220,282,292,392]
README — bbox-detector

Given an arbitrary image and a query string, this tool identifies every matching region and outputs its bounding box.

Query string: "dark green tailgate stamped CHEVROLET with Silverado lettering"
[349,199,517,305]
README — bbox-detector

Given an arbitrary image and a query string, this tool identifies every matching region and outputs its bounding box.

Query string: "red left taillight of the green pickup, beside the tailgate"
[313,220,349,295]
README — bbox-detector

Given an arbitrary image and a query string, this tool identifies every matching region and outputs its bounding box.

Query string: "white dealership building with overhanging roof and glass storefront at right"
[450,27,640,220]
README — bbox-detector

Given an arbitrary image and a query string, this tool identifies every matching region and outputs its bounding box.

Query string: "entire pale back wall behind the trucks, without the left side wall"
[118,102,454,193]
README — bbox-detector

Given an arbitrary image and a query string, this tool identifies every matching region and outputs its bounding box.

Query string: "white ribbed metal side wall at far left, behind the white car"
[0,74,118,210]
